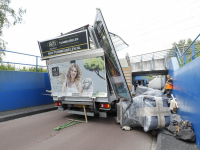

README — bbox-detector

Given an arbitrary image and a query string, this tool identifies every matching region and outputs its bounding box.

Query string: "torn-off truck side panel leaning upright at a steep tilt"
[94,9,131,100]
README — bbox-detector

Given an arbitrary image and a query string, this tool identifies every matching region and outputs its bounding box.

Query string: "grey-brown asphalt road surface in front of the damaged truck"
[0,110,153,150]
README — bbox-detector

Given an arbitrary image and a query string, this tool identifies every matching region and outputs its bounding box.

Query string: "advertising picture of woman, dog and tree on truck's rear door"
[49,56,107,97]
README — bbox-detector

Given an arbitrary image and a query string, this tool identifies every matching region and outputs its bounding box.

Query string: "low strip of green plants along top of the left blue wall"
[0,63,47,72]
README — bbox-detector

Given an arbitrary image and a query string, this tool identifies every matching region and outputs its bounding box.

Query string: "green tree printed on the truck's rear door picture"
[83,57,105,80]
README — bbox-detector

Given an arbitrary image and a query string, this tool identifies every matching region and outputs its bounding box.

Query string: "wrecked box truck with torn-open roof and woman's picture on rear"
[38,9,131,117]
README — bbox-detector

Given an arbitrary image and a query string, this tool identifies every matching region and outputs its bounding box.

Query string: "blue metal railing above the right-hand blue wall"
[173,34,200,66]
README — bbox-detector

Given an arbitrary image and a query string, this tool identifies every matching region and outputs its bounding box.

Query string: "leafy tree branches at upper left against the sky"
[0,0,26,60]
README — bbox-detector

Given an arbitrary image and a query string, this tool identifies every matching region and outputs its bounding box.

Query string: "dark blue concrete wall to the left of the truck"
[0,71,53,112]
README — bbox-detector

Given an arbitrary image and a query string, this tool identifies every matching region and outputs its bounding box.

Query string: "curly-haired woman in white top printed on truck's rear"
[62,63,83,96]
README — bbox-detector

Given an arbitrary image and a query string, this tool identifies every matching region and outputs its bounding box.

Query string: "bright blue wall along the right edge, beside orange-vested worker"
[169,57,200,148]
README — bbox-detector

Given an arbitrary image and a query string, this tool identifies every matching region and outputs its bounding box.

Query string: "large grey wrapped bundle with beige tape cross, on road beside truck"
[117,95,170,132]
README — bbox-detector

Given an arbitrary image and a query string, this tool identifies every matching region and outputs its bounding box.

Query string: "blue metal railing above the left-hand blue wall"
[0,49,47,72]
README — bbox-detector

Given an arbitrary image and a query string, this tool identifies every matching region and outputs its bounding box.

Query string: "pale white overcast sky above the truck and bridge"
[2,0,200,65]
